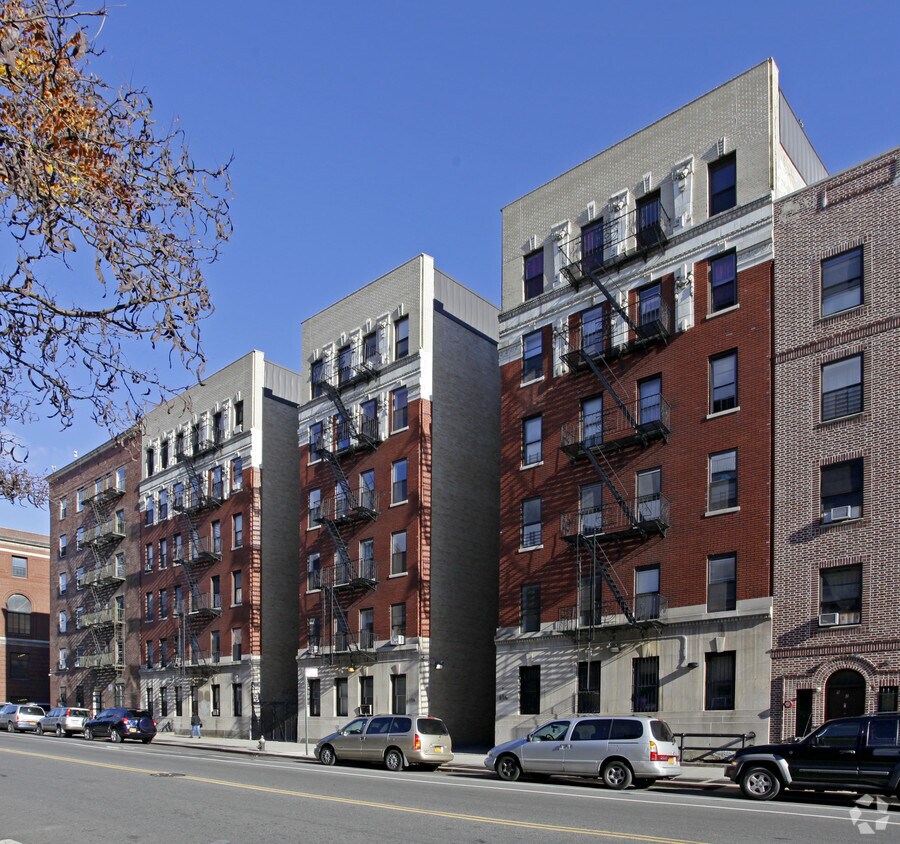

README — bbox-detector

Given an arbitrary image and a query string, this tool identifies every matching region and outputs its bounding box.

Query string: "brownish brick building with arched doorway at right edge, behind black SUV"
[772,149,900,738]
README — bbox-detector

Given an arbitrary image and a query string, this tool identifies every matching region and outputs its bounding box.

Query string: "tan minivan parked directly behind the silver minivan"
[315,715,453,771]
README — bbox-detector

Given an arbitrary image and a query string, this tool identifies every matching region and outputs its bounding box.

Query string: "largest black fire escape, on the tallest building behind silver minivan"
[557,198,672,636]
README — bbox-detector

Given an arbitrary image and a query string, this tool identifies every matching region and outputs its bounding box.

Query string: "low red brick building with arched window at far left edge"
[0,528,50,703]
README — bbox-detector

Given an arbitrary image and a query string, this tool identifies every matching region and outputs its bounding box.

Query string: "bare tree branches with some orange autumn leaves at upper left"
[0,0,231,503]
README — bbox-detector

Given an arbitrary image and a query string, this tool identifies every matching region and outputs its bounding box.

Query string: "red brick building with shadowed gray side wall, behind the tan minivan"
[299,255,499,743]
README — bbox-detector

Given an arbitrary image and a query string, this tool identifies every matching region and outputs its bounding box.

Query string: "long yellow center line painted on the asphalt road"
[0,748,700,844]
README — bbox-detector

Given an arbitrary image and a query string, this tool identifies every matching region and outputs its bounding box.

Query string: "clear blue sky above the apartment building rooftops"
[0,0,900,532]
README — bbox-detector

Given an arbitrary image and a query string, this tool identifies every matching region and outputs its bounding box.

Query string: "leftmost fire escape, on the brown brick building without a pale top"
[77,478,126,686]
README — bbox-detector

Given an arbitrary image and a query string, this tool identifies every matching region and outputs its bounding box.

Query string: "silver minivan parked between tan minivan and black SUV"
[484,715,681,789]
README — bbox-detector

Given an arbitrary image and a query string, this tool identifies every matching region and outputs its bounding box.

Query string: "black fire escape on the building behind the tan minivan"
[307,339,380,665]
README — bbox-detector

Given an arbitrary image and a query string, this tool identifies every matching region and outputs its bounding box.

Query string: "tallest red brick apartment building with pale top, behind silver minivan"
[496,62,824,740]
